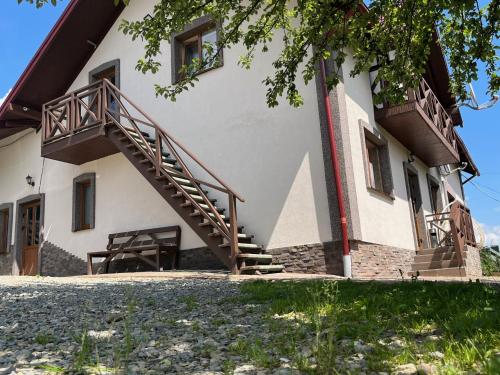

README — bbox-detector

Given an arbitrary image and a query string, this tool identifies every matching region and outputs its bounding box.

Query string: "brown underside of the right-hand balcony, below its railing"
[375,102,460,167]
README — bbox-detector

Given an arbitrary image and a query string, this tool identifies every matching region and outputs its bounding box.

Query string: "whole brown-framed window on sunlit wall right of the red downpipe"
[360,121,394,198]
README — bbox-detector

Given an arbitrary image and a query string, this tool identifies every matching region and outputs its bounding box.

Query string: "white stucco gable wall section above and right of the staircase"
[61,0,331,253]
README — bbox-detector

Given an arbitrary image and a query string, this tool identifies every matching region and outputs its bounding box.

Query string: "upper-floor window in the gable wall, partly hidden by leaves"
[172,17,222,83]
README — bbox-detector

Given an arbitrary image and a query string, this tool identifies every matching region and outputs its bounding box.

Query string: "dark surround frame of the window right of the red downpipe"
[359,120,395,200]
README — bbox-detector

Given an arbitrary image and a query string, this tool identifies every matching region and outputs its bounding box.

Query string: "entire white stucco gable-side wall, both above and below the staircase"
[0,0,331,268]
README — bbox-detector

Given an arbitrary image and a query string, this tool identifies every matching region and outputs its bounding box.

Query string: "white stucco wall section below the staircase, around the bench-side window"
[0,131,204,259]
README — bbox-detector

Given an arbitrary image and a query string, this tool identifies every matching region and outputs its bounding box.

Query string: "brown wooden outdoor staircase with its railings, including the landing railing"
[42,80,284,274]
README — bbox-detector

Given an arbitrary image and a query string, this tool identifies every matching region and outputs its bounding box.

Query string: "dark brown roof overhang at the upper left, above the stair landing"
[0,0,124,139]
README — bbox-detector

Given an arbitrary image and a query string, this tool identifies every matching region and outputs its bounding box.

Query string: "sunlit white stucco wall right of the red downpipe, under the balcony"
[343,57,461,249]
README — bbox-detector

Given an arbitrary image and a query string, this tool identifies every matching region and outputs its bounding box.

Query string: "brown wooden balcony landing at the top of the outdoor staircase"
[42,81,119,165]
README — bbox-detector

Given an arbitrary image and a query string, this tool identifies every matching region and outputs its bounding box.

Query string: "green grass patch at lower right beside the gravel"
[236,281,500,374]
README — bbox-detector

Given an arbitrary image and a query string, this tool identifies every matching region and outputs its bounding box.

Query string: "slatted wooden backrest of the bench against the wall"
[106,225,181,250]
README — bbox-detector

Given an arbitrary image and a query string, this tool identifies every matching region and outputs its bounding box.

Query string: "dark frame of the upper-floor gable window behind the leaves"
[171,16,224,84]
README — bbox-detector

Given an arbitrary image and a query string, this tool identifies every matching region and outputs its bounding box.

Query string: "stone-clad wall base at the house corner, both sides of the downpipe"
[267,241,415,279]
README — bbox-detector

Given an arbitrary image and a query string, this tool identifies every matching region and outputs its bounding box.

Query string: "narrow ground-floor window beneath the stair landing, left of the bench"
[73,173,95,232]
